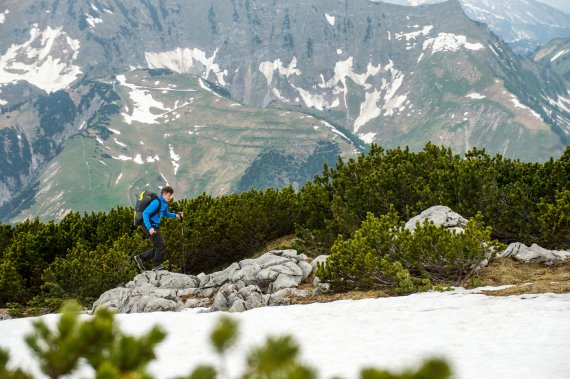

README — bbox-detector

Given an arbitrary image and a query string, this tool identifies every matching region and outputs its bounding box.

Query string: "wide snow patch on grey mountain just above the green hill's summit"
[144,47,228,86]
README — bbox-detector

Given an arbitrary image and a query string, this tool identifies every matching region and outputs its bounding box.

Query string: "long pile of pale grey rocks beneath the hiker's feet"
[93,250,318,313]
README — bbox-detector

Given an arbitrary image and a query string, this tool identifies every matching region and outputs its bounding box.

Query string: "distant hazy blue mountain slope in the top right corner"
[378,0,570,55]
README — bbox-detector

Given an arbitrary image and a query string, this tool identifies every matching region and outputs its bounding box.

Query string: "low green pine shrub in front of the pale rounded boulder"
[317,209,501,293]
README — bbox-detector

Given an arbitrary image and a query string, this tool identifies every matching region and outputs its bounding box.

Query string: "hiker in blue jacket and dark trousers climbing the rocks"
[133,186,184,271]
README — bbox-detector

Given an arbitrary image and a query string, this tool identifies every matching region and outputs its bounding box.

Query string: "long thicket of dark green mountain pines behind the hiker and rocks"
[0,144,570,309]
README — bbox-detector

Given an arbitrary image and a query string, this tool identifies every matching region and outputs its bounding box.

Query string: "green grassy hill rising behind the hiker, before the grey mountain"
[12,71,355,222]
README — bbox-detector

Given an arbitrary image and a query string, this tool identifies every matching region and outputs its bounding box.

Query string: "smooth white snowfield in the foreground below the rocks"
[0,289,570,379]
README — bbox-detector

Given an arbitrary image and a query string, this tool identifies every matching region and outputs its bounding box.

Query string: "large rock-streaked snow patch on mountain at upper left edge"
[0,24,81,92]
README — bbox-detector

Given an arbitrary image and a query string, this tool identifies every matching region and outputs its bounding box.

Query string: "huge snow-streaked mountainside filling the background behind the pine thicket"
[0,0,570,223]
